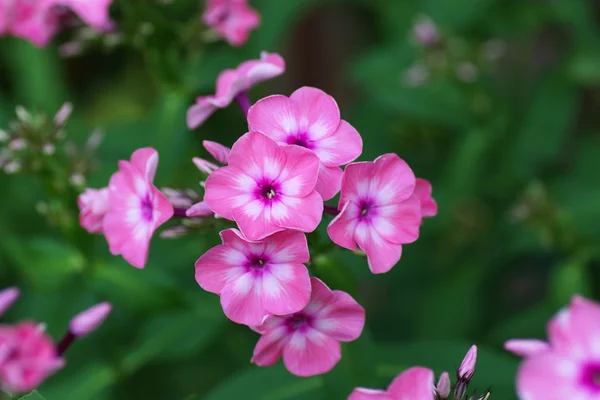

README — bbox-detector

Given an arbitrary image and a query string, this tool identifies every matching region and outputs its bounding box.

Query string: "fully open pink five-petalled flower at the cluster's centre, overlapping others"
[204,132,323,240]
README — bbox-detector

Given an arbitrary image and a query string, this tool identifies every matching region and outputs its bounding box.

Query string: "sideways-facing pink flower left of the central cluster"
[103,147,174,268]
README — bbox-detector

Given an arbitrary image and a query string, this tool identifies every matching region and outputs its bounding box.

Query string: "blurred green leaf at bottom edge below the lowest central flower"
[204,364,325,400]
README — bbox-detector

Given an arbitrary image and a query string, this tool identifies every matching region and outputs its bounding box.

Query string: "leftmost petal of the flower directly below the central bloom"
[196,245,247,294]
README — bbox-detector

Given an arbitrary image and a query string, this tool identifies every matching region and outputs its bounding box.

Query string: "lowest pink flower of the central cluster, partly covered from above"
[252,278,365,376]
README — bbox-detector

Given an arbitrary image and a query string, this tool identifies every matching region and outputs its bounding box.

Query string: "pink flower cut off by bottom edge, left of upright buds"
[348,367,435,400]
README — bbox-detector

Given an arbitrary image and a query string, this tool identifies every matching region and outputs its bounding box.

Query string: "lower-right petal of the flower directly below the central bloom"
[262,263,311,315]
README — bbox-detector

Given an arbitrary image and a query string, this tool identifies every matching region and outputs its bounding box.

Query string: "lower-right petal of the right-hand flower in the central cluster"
[371,197,421,244]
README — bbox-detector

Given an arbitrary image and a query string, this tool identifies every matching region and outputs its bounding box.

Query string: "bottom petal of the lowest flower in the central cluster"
[283,328,342,376]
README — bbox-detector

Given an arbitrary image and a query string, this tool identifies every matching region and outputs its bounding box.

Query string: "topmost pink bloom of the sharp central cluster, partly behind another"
[248,87,362,200]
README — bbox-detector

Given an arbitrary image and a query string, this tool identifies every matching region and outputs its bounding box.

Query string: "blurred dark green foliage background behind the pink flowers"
[0,0,600,400]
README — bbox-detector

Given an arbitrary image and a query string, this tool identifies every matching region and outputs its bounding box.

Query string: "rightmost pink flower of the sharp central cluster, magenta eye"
[327,153,421,274]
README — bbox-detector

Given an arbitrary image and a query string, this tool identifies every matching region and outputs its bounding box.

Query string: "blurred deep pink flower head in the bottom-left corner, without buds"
[0,322,64,393]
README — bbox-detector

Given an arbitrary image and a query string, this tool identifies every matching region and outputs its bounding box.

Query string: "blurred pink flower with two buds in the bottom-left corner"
[0,288,111,393]
